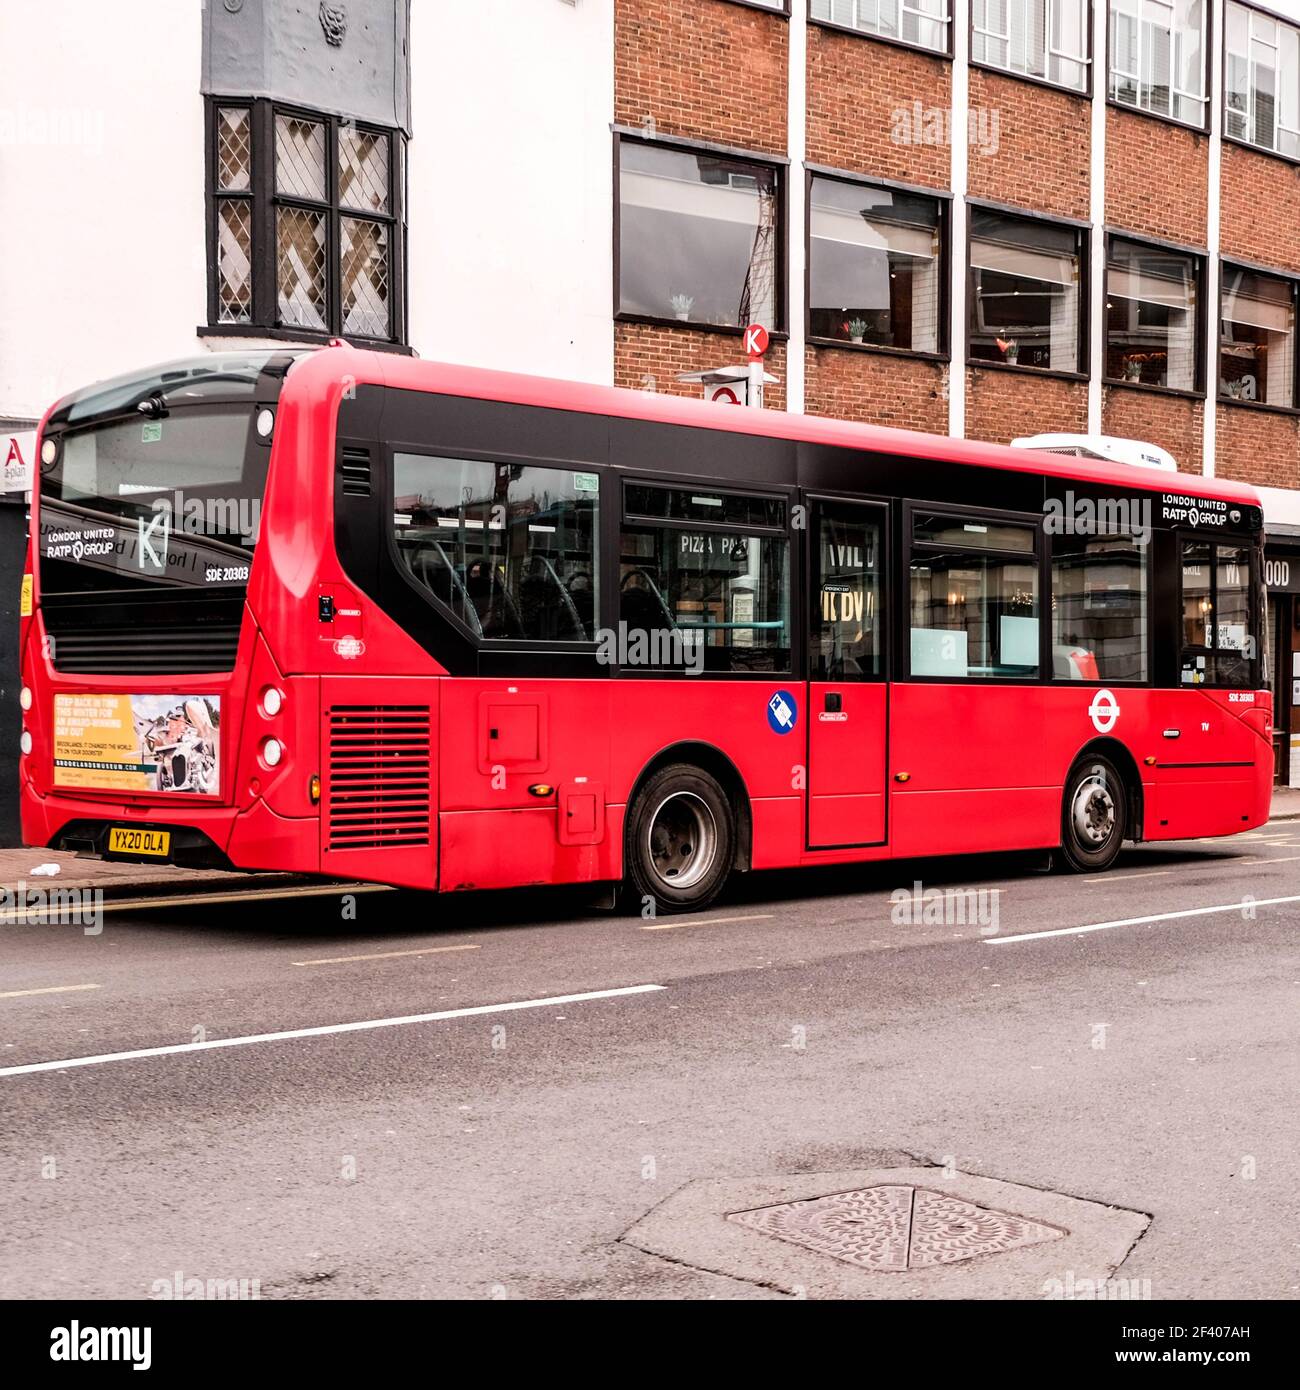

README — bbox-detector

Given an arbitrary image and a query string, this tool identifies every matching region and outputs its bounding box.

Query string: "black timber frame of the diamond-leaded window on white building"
[197,96,409,352]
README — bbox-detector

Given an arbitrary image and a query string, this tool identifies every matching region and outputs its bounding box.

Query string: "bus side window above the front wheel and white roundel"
[1051,535,1147,684]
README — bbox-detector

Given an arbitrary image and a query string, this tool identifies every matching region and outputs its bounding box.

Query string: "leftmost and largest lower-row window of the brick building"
[619,139,783,329]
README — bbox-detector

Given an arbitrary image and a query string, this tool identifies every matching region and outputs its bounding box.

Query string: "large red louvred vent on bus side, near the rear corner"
[324,705,432,849]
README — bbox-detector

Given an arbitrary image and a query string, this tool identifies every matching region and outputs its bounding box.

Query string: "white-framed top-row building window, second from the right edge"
[1111,0,1207,126]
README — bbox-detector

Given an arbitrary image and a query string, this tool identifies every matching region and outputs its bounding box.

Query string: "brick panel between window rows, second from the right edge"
[1105,107,1210,246]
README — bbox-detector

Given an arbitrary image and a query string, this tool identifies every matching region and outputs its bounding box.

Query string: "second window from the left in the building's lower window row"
[808,178,947,352]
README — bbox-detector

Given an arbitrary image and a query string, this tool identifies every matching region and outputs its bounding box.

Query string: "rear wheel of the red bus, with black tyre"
[624,763,736,912]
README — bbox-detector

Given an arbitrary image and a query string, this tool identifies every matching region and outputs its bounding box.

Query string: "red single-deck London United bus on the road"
[21,345,1272,912]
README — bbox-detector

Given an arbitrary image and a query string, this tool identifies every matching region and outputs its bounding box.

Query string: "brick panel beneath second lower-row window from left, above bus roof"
[805,346,948,434]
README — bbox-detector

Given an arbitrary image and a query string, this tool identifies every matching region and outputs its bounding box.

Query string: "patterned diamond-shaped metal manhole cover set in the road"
[727,1184,1069,1272]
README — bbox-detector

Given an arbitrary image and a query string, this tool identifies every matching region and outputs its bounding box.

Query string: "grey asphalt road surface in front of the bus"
[0,823,1300,1298]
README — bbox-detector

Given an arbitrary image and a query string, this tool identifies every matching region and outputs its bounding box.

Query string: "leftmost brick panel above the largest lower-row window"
[615,0,790,154]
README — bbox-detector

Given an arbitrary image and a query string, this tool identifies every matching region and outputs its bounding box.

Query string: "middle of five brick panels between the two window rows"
[969,68,1091,218]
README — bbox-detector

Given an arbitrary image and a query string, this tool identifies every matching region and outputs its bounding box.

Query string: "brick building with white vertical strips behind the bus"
[615,0,1300,763]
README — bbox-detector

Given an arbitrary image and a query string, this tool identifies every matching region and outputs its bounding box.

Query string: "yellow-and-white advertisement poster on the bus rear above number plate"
[54,695,221,796]
